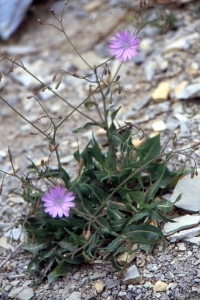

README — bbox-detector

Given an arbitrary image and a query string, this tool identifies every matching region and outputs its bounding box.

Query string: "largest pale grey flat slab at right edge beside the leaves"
[170,174,200,212]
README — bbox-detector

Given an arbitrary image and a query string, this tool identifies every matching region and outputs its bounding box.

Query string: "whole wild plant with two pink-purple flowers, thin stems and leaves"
[0,1,199,285]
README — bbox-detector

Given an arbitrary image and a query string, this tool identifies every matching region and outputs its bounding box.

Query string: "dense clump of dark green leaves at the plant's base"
[21,128,182,285]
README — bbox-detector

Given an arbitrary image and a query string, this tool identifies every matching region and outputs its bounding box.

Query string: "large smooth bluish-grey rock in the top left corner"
[0,0,33,41]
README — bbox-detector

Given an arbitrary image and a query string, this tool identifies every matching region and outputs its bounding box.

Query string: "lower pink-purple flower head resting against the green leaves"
[41,185,75,218]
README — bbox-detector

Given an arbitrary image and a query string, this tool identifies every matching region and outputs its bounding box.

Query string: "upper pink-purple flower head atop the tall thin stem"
[109,30,140,62]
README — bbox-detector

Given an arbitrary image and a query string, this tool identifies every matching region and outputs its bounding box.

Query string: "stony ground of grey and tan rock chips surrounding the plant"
[0,0,200,300]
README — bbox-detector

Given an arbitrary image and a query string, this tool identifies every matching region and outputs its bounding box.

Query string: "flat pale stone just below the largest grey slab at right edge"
[163,215,200,235]
